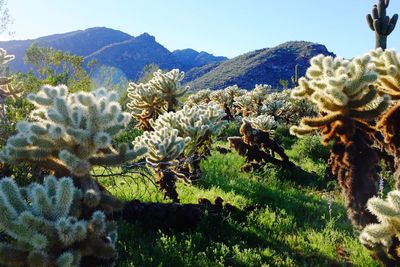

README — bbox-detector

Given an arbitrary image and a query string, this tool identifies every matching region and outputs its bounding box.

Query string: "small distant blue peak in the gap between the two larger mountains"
[172,48,228,71]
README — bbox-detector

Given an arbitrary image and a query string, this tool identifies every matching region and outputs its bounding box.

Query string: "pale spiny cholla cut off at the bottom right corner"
[360,191,400,266]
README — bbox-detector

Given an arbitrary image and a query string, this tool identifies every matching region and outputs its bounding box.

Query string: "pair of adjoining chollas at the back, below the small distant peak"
[127,69,189,131]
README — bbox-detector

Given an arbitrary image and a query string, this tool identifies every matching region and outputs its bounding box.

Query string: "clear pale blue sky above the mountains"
[3,0,400,57]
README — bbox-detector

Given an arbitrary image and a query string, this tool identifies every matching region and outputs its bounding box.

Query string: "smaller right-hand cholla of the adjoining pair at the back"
[149,69,189,112]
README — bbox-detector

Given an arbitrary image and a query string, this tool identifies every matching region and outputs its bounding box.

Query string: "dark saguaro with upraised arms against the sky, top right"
[367,0,399,50]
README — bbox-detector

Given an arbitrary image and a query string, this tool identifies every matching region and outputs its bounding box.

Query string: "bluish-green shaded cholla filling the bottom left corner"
[0,176,117,267]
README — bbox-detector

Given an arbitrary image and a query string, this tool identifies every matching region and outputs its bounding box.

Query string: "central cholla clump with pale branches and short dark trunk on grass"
[133,105,226,202]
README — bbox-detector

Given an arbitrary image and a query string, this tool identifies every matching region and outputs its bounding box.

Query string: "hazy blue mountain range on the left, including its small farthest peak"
[0,27,226,80]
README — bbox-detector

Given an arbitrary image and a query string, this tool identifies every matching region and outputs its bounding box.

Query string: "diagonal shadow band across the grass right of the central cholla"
[198,153,352,233]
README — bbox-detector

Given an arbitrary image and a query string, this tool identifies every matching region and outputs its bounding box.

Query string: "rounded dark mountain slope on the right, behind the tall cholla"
[184,41,334,90]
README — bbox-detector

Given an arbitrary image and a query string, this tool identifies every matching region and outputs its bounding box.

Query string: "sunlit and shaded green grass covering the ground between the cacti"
[108,140,377,267]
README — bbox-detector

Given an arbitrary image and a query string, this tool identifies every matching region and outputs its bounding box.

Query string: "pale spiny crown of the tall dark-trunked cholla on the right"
[291,55,390,136]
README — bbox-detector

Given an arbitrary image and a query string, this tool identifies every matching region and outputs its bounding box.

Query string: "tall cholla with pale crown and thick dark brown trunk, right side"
[291,55,390,226]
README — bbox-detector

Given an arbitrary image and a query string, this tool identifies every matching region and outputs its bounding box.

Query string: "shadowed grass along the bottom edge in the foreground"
[117,214,350,266]
